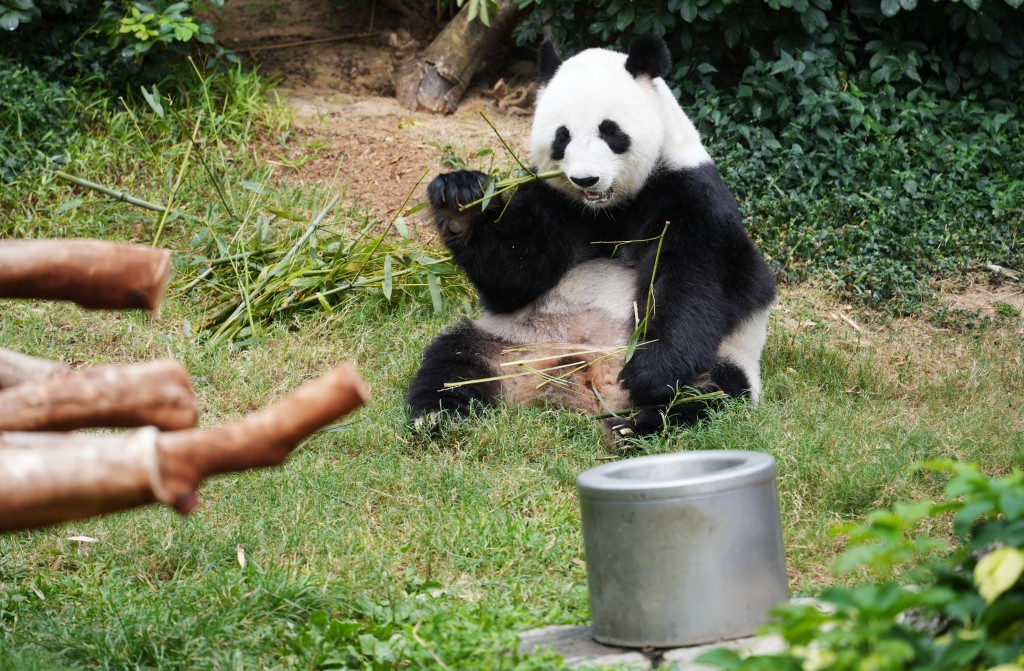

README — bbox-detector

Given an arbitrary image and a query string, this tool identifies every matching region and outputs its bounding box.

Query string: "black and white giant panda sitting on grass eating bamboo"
[408,35,775,443]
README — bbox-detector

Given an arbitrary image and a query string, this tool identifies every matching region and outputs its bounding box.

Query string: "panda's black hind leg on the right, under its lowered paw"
[605,358,752,448]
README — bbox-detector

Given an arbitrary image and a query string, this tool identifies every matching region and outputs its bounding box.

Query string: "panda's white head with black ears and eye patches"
[530,35,678,208]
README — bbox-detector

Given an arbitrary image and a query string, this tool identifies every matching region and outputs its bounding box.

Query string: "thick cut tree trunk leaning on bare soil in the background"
[395,0,519,114]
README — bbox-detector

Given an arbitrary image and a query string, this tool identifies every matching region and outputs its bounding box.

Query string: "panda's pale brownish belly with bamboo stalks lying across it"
[474,259,637,414]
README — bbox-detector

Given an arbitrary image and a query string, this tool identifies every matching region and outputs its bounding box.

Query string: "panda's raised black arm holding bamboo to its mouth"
[427,170,593,312]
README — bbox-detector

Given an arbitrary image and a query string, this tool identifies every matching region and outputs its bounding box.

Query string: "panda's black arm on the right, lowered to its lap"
[620,164,775,405]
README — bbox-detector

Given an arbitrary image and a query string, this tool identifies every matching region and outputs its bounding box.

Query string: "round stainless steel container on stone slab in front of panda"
[577,450,788,647]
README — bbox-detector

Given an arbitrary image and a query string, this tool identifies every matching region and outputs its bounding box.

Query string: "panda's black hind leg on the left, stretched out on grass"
[407,320,501,432]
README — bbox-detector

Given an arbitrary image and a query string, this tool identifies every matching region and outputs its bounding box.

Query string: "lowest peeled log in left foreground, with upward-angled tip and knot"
[0,365,369,532]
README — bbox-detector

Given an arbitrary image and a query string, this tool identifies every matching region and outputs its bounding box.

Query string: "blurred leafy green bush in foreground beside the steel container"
[700,462,1024,671]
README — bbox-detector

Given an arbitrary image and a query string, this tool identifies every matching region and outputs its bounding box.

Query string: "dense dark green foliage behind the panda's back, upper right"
[516,0,1024,310]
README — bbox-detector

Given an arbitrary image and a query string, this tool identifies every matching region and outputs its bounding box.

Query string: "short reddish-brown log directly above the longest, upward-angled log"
[0,359,198,431]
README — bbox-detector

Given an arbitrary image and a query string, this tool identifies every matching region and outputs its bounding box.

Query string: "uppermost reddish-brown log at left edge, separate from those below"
[0,239,171,309]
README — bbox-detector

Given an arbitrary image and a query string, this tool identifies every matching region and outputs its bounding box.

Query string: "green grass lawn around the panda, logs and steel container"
[0,65,1024,669]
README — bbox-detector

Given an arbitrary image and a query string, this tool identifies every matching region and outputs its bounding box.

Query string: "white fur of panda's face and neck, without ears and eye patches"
[530,49,712,205]
